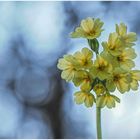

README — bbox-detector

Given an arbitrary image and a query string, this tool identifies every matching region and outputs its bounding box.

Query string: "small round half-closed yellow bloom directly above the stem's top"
[93,83,106,95]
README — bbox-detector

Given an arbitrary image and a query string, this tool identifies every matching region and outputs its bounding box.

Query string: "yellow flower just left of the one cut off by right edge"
[106,68,130,93]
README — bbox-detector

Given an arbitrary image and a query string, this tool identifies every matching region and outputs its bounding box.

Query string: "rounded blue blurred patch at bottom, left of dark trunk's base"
[16,108,53,139]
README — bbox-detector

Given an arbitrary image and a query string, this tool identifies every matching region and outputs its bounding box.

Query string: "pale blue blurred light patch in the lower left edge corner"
[0,88,23,138]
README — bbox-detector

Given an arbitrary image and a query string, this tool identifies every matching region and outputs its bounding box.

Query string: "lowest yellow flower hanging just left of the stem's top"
[74,91,95,107]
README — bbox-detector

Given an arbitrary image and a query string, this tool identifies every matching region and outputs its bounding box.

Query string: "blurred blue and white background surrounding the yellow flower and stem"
[0,1,140,139]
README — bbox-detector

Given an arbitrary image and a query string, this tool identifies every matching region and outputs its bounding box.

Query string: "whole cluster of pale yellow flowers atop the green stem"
[57,18,140,108]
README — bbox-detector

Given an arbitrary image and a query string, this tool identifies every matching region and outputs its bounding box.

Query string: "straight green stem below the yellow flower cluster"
[96,107,102,139]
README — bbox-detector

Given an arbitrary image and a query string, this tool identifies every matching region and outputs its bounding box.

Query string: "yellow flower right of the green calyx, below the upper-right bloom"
[102,33,125,56]
